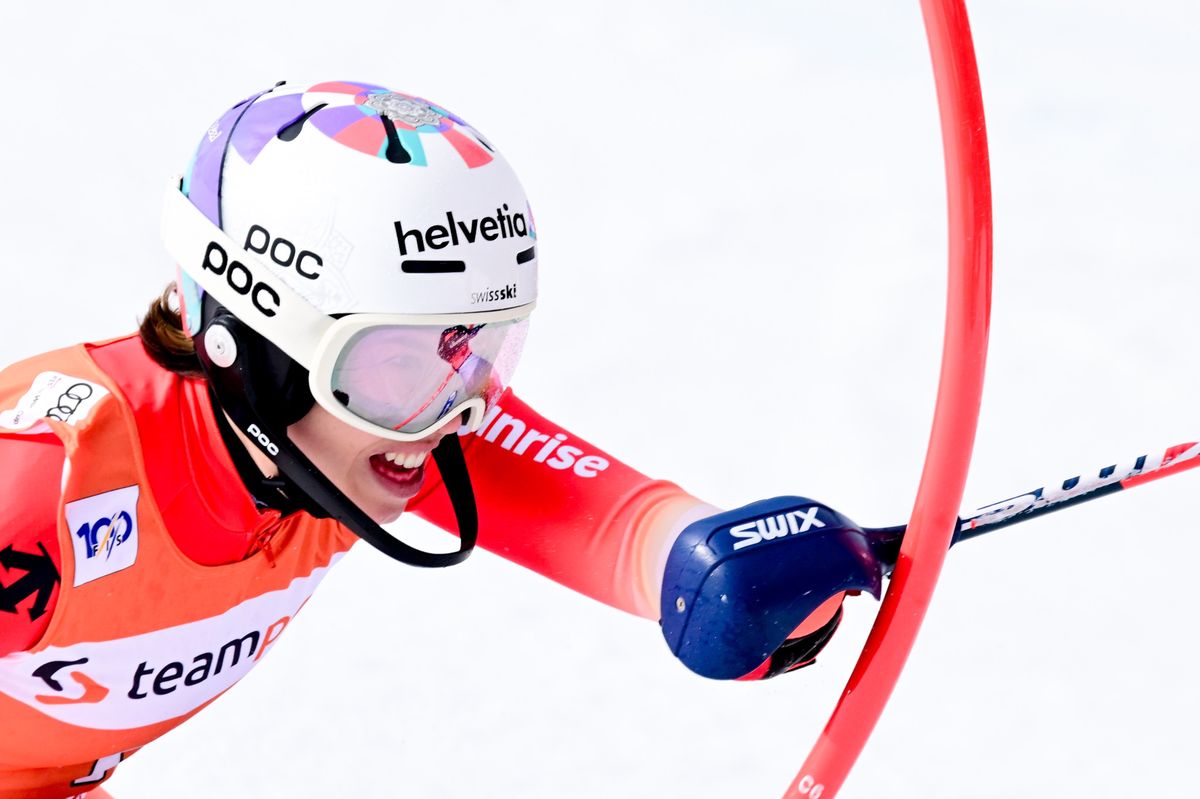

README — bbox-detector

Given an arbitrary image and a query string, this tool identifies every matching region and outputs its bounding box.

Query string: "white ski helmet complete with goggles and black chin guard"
[163,82,538,565]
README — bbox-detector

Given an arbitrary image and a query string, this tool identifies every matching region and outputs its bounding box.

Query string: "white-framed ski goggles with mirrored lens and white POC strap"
[163,182,534,441]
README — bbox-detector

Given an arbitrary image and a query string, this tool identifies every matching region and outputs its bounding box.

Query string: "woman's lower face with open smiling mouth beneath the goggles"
[288,404,458,524]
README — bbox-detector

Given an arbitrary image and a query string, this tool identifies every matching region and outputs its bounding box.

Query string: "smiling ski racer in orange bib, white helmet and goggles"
[0,82,844,798]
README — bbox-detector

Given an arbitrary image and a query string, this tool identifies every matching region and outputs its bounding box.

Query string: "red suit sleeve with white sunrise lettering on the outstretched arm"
[409,390,718,619]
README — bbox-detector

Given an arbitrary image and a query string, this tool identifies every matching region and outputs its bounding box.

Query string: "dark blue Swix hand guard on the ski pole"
[661,497,890,680]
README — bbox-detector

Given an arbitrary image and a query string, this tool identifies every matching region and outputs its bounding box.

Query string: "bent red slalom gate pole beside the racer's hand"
[784,0,991,799]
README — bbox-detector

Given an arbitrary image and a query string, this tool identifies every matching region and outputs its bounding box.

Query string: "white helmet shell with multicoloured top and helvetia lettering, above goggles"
[175,82,536,334]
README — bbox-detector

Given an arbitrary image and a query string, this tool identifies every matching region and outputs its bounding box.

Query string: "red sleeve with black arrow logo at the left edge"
[0,435,65,657]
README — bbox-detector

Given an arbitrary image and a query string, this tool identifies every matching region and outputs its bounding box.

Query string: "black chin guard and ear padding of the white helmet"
[196,296,479,567]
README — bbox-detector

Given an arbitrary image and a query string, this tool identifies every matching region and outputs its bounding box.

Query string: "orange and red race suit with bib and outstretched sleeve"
[0,336,840,799]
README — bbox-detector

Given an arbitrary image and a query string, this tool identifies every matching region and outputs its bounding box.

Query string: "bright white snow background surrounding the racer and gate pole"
[0,0,1200,799]
